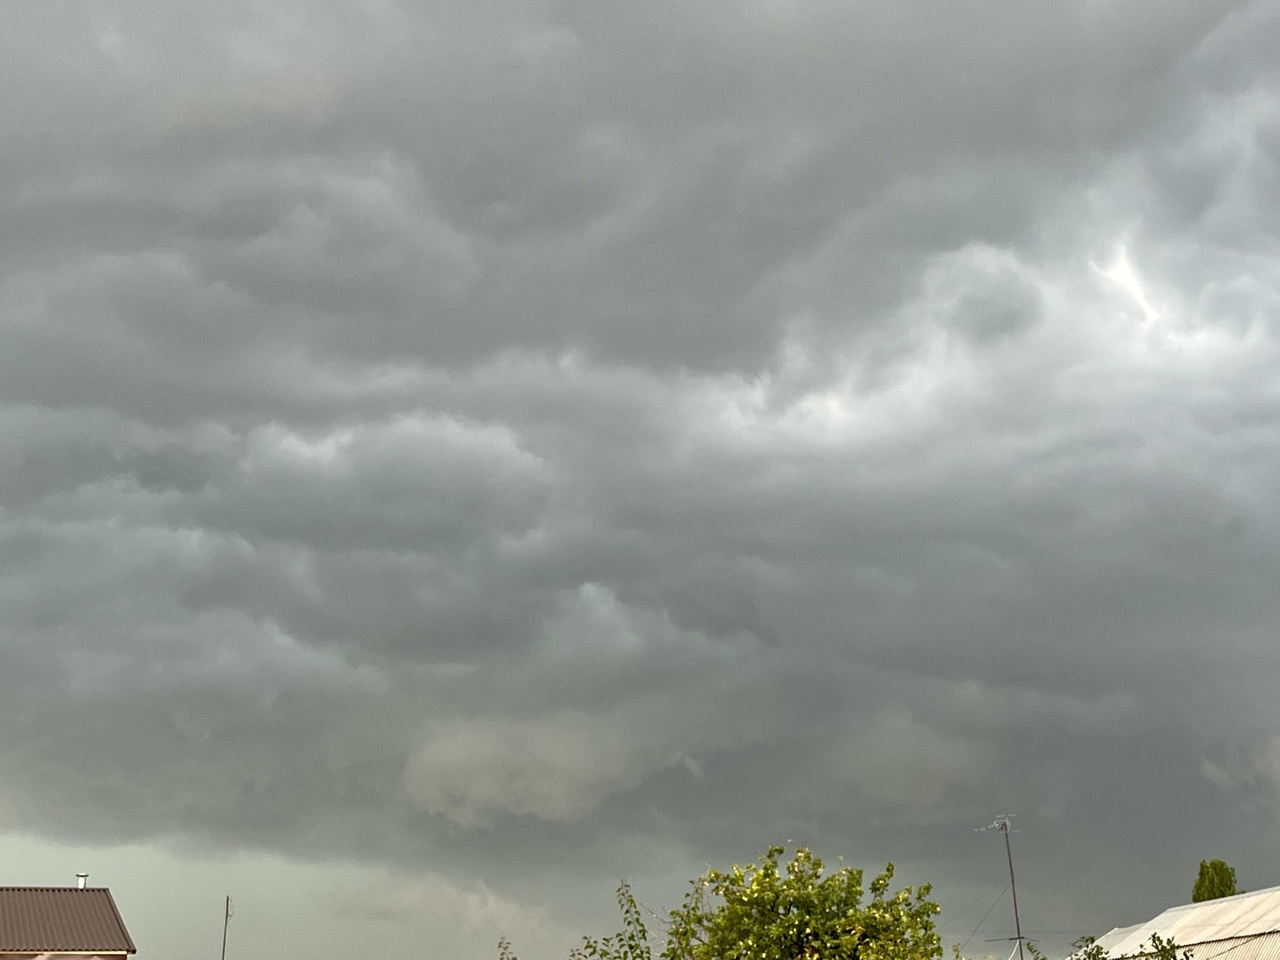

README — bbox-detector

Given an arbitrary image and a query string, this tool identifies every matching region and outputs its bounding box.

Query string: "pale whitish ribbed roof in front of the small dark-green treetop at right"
[1098,887,1280,960]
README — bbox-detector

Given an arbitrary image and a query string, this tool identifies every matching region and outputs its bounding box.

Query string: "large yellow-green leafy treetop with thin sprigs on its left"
[499,846,942,960]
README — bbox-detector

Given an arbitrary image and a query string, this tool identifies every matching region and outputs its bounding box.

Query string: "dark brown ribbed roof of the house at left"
[0,887,136,954]
